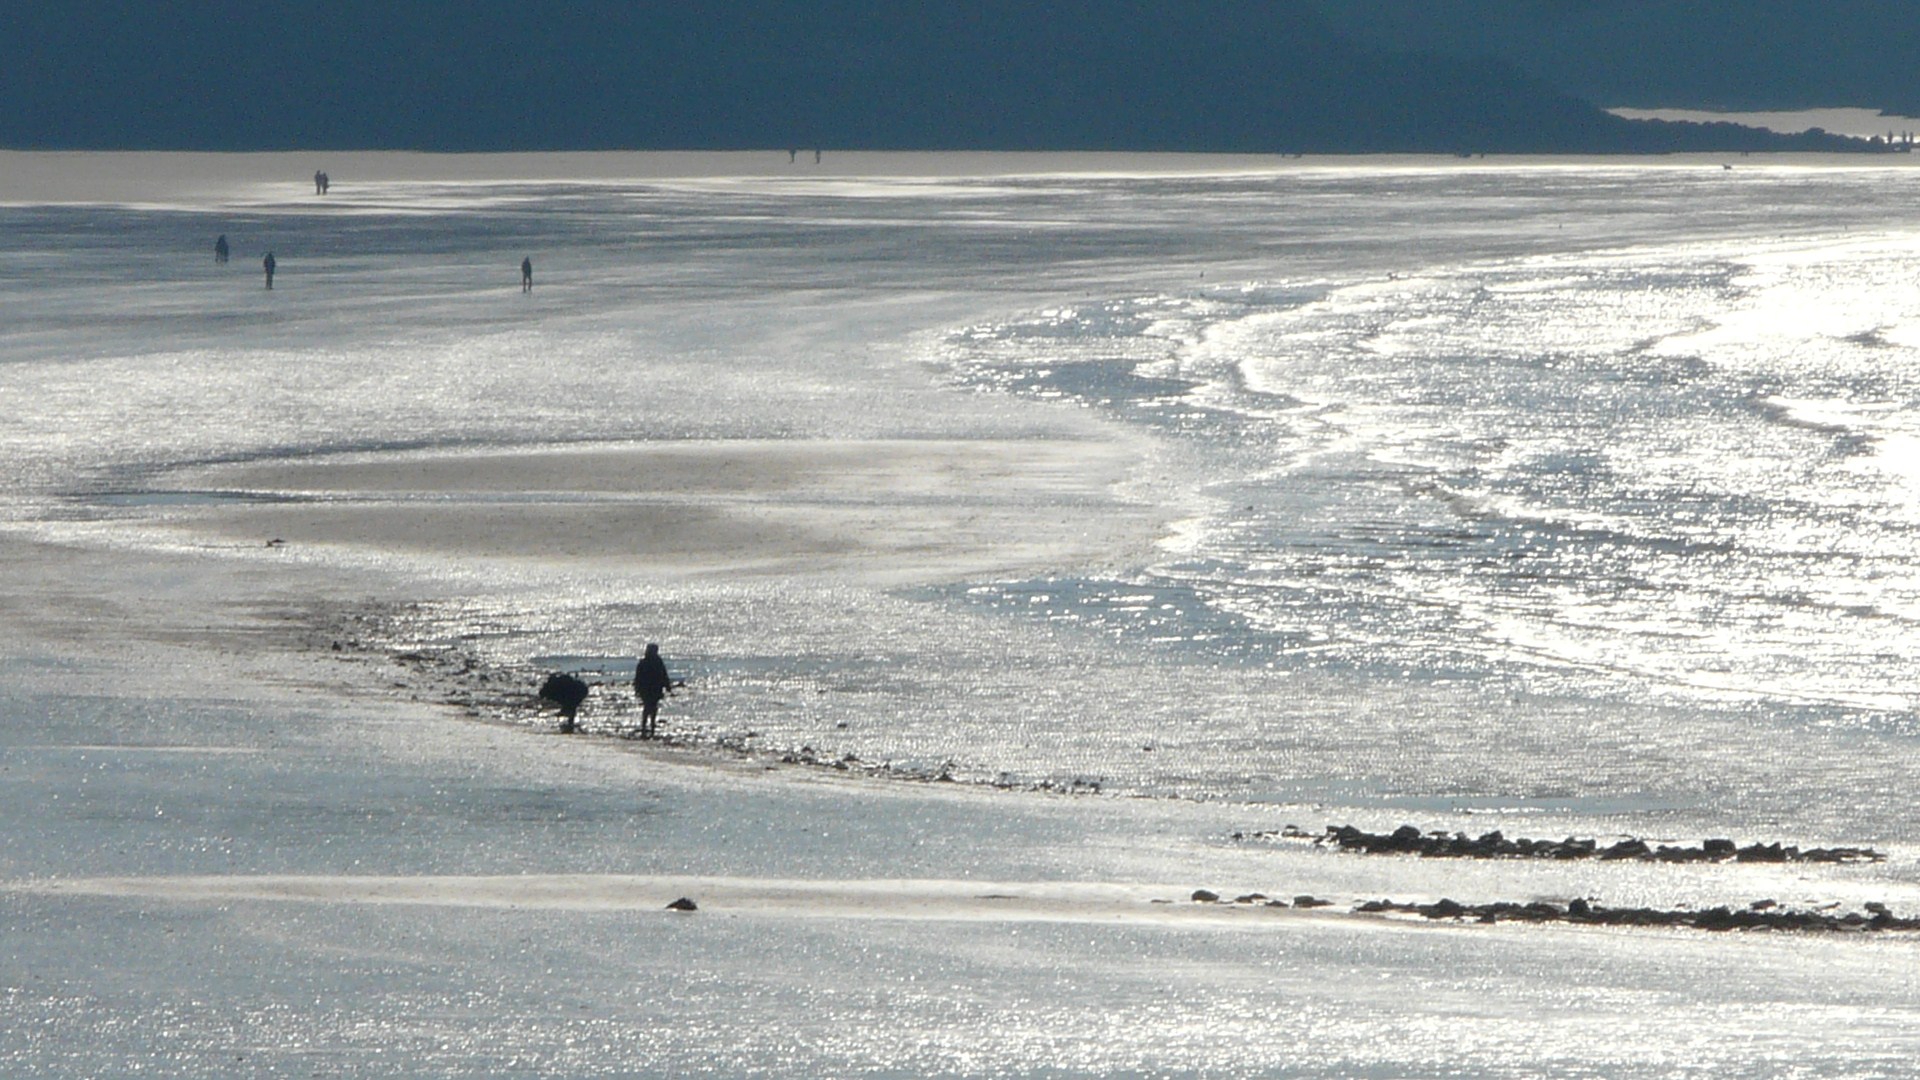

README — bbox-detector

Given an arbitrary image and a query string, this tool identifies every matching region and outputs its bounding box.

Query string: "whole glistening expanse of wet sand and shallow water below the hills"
[11,148,1920,1078]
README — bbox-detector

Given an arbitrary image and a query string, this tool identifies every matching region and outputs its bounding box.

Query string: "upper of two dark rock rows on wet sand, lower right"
[1233,824,1885,863]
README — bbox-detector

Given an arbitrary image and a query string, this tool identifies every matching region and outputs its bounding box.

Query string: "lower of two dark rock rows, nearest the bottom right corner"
[1354,899,1920,932]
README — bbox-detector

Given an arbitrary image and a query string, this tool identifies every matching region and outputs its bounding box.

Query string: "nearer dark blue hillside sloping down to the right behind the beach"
[0,0,1881,152]
